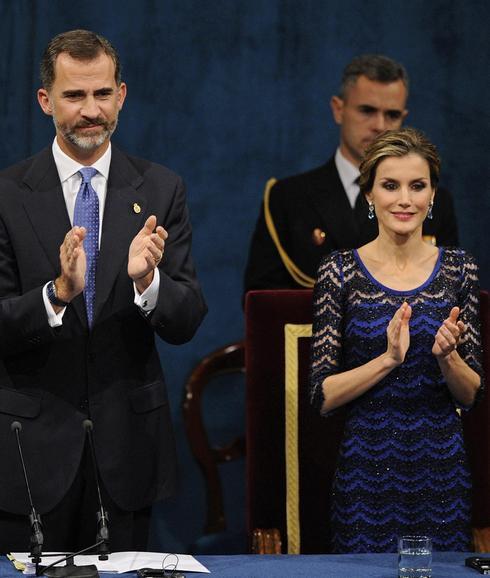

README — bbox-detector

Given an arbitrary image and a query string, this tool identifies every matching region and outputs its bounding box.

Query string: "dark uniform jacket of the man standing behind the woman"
[245,157,458,292]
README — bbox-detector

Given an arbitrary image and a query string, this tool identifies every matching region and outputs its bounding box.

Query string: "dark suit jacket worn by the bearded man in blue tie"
[0,146,206,513]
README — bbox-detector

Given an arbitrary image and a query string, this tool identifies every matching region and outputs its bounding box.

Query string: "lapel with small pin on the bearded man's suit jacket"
[95,145,147,321]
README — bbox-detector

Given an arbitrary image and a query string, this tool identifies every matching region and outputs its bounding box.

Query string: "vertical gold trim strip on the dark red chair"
[284,323,312,554]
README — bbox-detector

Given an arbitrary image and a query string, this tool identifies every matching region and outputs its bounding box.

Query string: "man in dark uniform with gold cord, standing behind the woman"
[245,55,458,292]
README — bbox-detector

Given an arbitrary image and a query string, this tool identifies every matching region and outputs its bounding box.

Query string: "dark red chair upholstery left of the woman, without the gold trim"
[245,290,343,553]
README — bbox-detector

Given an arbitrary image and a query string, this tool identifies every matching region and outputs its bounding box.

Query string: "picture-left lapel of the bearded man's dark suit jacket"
[23,147,87,324]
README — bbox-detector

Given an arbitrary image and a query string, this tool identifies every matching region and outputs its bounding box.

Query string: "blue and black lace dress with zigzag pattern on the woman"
[311,249,482,553]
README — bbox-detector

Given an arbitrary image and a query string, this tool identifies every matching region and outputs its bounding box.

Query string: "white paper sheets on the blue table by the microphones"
[11,552,210,574]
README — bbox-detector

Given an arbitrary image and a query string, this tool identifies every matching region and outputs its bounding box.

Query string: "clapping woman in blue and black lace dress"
[311,128,482,553]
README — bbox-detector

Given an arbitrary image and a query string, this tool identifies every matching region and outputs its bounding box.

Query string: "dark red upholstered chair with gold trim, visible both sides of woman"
[245,290,490,553]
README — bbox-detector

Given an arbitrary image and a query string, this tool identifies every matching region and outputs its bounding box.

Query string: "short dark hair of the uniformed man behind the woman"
[339,54,408,99]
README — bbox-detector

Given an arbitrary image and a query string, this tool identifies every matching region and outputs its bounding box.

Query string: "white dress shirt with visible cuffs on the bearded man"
[43,137,160,327]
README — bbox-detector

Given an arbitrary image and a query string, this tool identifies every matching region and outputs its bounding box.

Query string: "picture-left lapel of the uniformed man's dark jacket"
[306,157,359,247]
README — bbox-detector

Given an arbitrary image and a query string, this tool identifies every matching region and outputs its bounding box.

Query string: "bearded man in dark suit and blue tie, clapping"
[0,30,207,552]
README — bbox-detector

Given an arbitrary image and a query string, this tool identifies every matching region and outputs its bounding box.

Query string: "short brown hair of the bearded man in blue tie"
[40,30,121,91]
